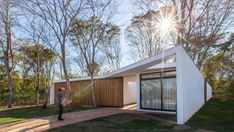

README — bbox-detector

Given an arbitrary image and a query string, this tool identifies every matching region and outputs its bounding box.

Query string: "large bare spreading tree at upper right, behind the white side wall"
[130,0,234,69]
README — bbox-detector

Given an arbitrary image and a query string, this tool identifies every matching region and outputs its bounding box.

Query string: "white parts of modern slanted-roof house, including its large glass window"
[50,46,212,124]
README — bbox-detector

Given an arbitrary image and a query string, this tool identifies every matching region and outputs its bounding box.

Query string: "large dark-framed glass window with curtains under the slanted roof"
[140,71,176,111]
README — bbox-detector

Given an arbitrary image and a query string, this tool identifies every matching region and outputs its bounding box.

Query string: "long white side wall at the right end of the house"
[176,47,211,124]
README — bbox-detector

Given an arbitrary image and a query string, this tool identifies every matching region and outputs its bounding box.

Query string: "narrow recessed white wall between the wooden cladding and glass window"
[123,76,137,105]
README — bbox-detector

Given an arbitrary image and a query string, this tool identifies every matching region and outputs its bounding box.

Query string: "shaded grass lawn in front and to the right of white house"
[50,99,234,132]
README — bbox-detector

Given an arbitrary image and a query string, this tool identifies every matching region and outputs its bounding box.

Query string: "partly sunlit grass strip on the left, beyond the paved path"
[0,105,92,124]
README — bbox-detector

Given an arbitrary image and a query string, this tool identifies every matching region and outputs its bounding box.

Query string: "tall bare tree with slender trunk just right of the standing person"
[24,0,86,103]
